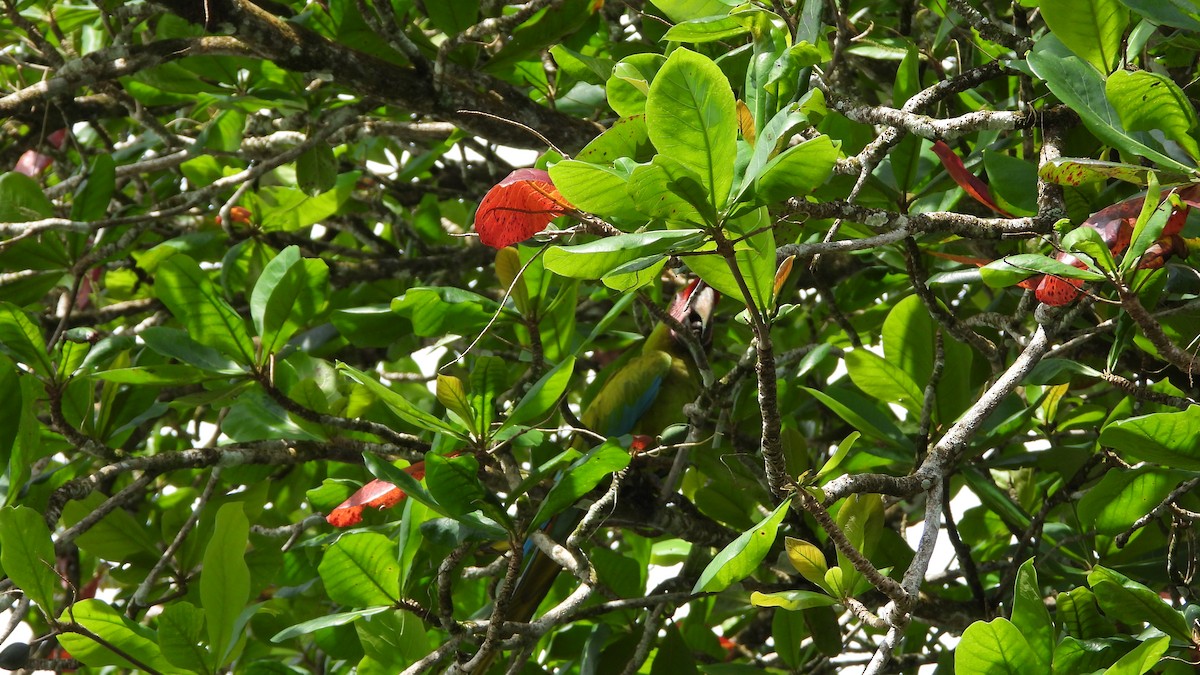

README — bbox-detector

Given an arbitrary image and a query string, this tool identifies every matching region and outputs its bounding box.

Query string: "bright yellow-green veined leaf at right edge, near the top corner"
[1104,70,1200,159]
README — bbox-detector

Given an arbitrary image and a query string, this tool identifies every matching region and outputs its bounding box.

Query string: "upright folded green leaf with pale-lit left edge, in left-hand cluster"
[250,246,329,358]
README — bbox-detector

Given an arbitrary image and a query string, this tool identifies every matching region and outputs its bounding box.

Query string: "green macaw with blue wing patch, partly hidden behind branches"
[475,280,719,658]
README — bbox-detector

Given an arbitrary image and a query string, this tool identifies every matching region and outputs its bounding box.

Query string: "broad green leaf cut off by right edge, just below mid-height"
[1100,406,1200,471]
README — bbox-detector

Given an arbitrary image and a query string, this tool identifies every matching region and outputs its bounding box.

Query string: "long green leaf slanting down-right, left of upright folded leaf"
[154,253,254,365]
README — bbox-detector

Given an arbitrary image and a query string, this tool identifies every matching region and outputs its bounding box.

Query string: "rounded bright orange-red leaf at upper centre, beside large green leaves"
[475,169,575,249]
